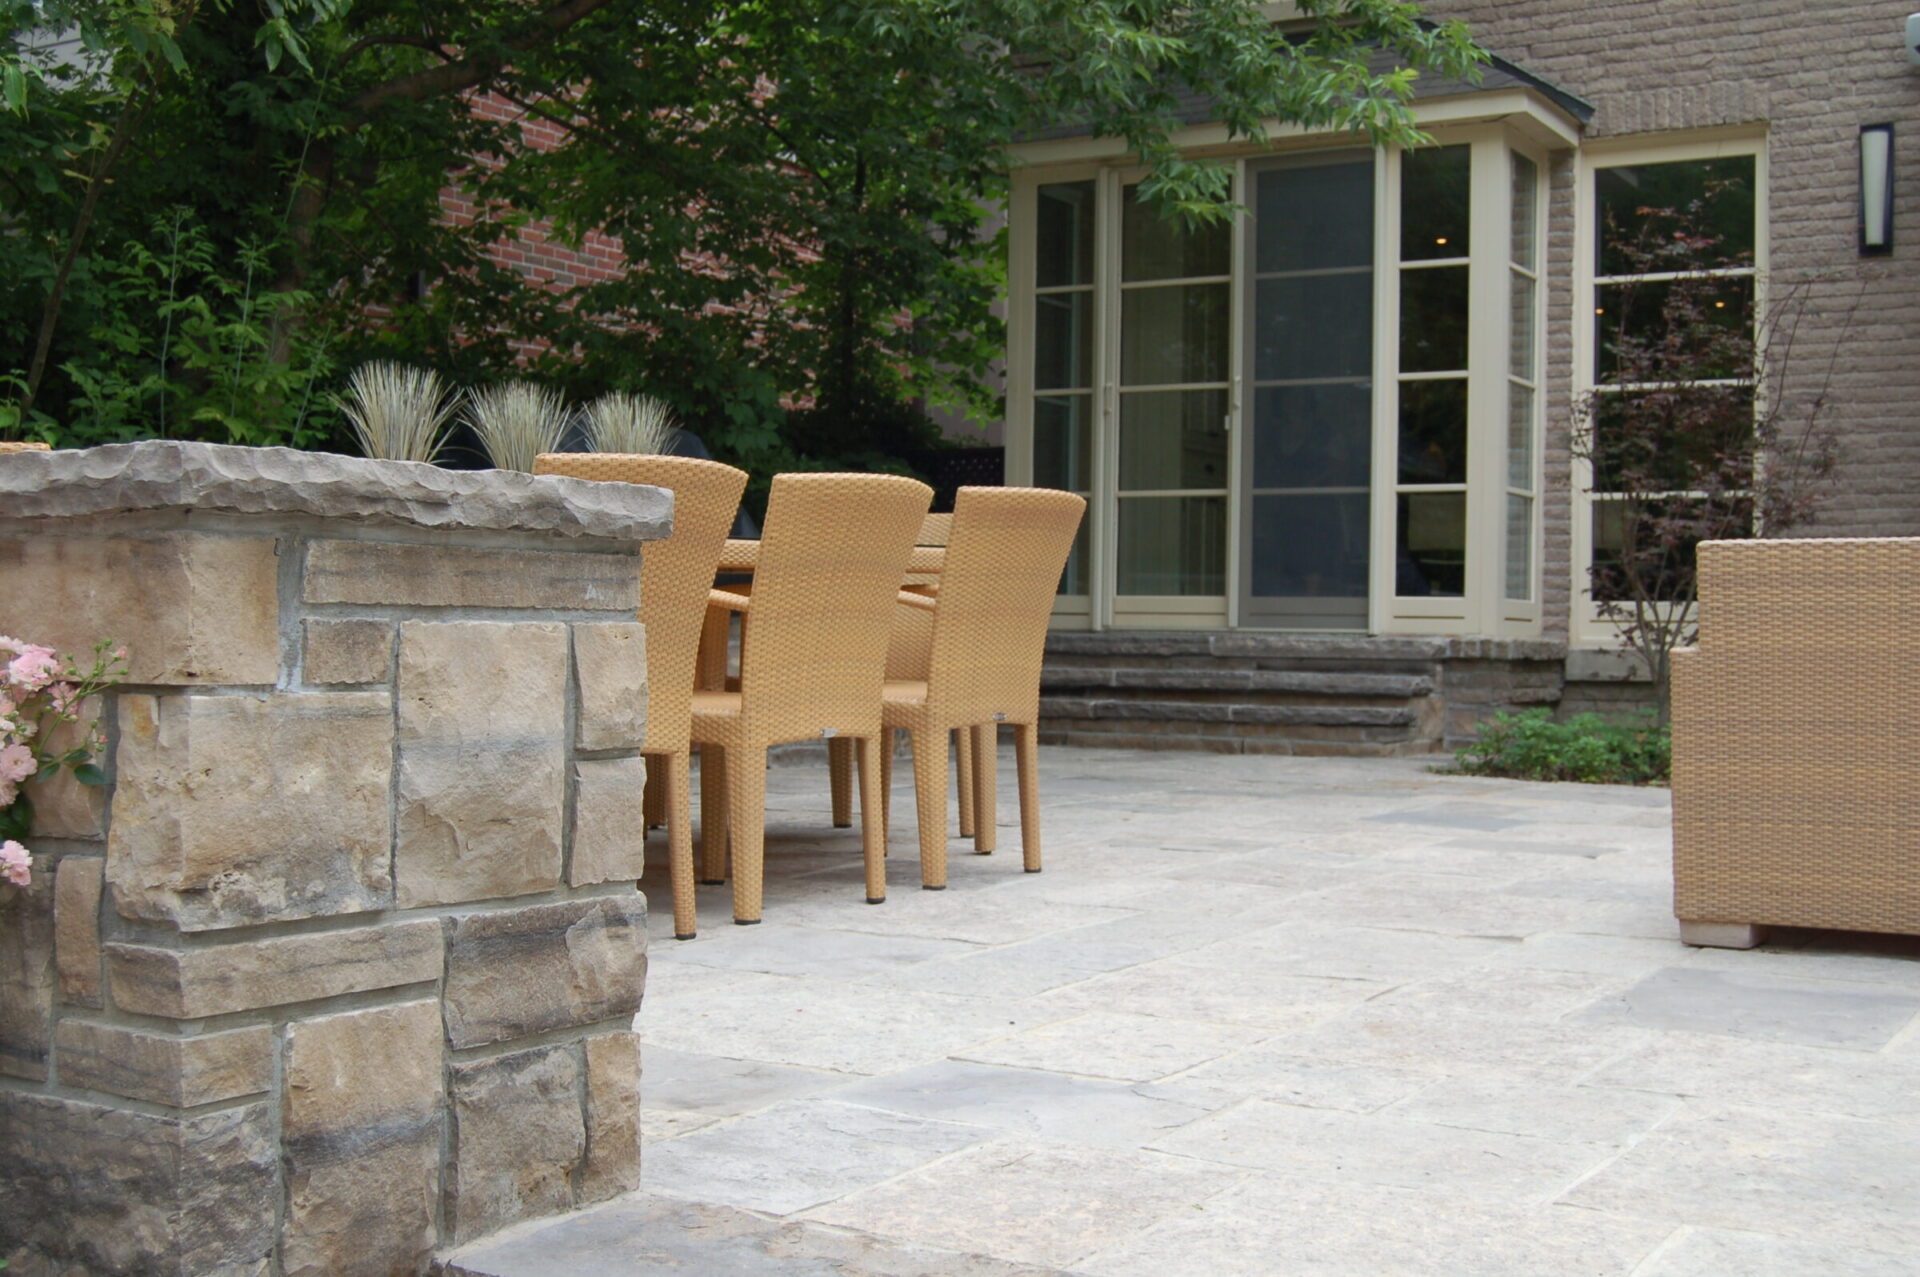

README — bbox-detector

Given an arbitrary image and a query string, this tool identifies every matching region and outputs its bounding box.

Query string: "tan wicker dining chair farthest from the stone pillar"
[881,488,1087,891]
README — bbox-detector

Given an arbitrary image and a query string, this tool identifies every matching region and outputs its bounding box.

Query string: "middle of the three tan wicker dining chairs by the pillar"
[693,474,933,924]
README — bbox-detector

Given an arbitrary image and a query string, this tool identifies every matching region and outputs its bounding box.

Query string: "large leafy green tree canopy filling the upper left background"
[0,0,1484,469]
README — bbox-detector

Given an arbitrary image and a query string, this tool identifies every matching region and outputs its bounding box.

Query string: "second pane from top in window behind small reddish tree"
[1594,277,1753,382]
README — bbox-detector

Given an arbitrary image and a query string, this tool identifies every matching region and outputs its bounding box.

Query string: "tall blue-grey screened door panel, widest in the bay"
[1238,152,1373,630]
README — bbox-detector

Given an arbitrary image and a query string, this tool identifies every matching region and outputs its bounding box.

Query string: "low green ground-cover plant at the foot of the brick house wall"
[1453,709,1672,785]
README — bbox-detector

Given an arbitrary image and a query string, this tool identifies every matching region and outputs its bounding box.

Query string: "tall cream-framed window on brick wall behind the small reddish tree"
[1574,140,1764,639]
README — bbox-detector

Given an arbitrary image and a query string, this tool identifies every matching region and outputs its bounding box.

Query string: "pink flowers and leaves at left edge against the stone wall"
[0,636,127,887]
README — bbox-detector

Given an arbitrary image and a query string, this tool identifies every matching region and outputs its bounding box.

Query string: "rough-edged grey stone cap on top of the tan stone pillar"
[0,440,674,542]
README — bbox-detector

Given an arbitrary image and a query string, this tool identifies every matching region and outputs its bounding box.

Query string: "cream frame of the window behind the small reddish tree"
[1567,129,1770,651]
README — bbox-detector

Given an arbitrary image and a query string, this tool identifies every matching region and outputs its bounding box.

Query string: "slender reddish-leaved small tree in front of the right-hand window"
[1572,181,1857,724]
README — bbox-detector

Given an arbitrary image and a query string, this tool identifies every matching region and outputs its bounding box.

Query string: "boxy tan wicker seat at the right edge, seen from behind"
[1672,540,1920,949]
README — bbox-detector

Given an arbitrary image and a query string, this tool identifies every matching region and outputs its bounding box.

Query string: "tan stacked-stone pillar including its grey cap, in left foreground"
[0,444,670,1275]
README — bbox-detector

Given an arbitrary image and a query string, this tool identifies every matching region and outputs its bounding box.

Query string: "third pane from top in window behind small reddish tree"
[1588,386,1755,492]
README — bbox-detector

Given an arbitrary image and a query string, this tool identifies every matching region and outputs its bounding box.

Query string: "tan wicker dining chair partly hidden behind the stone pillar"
[534,453,747,939]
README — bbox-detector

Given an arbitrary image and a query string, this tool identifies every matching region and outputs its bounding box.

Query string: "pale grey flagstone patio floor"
[447,749,1920,1277]
